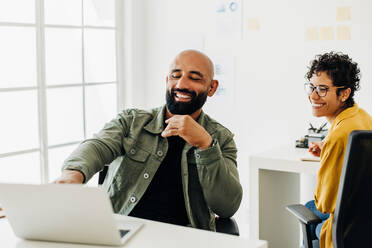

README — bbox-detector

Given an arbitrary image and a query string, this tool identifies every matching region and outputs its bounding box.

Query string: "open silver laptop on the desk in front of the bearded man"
[0,183,143,246]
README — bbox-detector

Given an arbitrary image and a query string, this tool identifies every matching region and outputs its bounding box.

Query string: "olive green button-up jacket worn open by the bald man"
[63,106,242,230]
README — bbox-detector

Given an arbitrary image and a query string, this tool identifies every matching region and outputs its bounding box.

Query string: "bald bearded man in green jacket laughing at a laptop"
[55,50,242,230]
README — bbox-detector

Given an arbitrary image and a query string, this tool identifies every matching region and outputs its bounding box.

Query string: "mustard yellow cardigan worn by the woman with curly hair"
[314,104,372,248]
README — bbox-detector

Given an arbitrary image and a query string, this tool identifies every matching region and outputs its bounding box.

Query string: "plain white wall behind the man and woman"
[124,0,372,236]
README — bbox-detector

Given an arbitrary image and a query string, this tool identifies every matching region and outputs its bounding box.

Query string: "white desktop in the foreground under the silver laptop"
[0,215,268,248]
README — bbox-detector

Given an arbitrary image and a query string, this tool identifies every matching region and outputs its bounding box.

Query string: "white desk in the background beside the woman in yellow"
[248,146,320,248]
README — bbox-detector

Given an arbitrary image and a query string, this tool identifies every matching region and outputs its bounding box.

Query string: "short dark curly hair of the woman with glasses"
[305,52,360,108]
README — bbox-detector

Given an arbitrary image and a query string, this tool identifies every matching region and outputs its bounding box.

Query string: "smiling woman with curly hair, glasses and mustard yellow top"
[305,52,372,248]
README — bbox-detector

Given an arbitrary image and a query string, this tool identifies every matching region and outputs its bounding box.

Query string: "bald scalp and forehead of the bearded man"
[169,50,214,81]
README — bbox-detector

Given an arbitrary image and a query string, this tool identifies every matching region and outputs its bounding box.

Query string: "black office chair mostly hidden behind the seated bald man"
[98,165,239,236]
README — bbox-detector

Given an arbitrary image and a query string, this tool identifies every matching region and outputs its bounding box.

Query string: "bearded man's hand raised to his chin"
[161,115,213,150]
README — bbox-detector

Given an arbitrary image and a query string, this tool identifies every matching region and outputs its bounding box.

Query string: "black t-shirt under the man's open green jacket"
[129,136,189,226]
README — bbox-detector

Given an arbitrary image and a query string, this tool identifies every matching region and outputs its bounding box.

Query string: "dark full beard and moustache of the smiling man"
[166,89,208,115]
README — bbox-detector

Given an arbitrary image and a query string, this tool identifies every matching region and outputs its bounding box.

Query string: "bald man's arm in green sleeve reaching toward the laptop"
[54,115,126,183]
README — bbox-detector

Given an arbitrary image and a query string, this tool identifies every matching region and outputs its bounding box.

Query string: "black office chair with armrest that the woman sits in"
[286,130,372,248]
